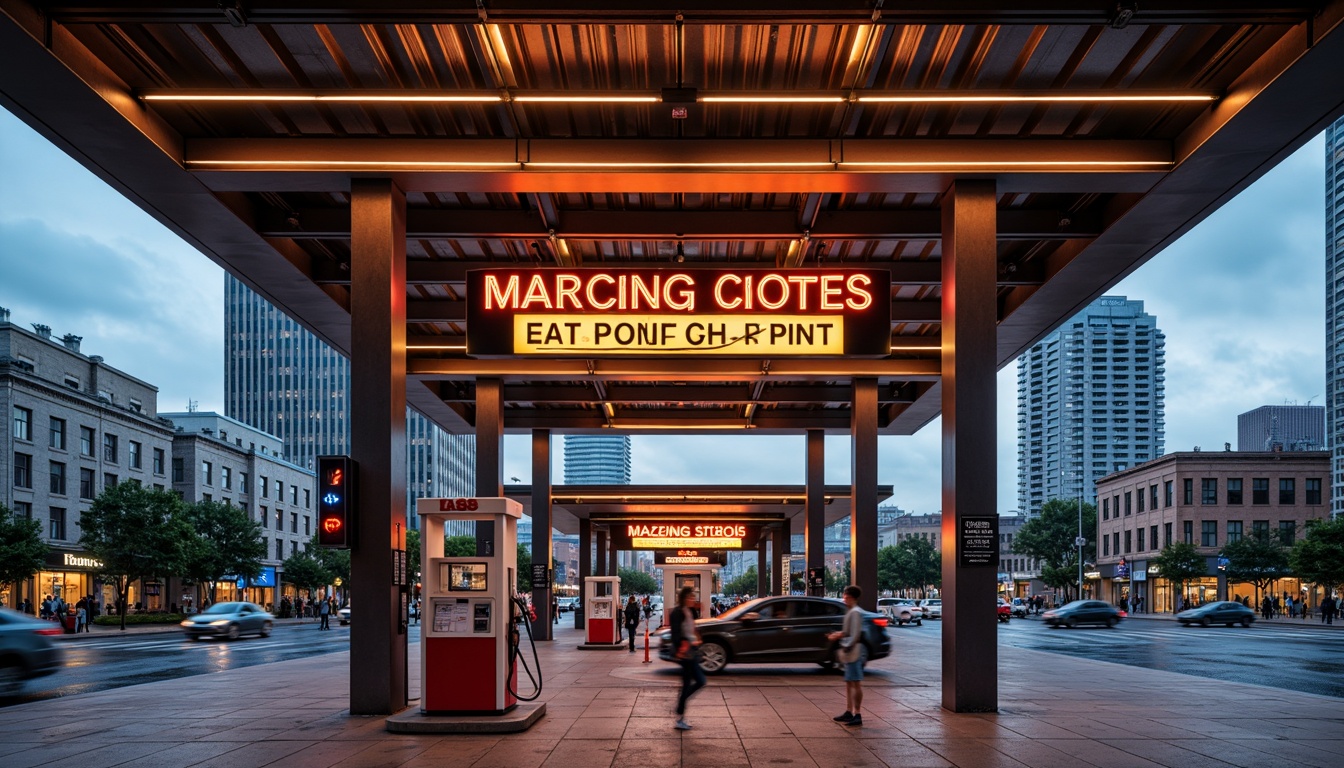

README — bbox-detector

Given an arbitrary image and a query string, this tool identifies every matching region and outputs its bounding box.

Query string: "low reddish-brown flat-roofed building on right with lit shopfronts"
[1087,451,1331,612]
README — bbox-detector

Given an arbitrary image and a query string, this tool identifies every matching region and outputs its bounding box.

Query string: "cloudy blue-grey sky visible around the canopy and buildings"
[0,109,1325,512]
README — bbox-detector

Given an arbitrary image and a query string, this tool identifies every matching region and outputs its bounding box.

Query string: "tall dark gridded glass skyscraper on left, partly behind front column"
[224,274,476,533]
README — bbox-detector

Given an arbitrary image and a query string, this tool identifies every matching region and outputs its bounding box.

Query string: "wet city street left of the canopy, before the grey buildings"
[0,620,370,707]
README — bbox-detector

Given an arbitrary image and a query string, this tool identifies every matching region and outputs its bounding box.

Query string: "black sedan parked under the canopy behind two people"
[657,596,891,673]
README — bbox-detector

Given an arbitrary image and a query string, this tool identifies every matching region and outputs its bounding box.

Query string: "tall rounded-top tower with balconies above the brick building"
[1017,296,1165,515]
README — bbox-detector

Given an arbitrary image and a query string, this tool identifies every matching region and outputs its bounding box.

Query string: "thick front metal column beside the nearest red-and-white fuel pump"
[349,179,406,714]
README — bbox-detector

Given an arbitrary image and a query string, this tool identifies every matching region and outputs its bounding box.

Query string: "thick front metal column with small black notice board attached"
[942,180,999,712]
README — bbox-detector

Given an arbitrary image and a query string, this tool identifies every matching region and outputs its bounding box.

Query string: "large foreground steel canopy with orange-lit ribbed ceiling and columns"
[0,0,1344,713]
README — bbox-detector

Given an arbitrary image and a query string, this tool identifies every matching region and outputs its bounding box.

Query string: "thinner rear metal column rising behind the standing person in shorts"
[849,379,878,611]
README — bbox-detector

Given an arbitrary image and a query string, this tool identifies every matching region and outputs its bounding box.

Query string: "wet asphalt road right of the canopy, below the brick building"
[892,617,1344,698]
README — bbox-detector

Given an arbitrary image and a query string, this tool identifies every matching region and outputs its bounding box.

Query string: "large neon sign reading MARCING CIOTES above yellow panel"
[466,269,891,356]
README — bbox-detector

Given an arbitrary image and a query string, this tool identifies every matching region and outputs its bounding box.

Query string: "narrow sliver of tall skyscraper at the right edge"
[1325,117,1344,516]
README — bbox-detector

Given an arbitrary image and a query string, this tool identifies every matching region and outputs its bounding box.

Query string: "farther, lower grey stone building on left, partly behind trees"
[164,412,317,607]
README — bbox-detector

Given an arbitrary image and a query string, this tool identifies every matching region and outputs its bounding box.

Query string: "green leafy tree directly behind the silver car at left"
[181,502,266,603]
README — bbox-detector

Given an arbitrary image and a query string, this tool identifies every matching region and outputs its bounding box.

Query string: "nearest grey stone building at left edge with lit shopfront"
[0,308,173,611]
